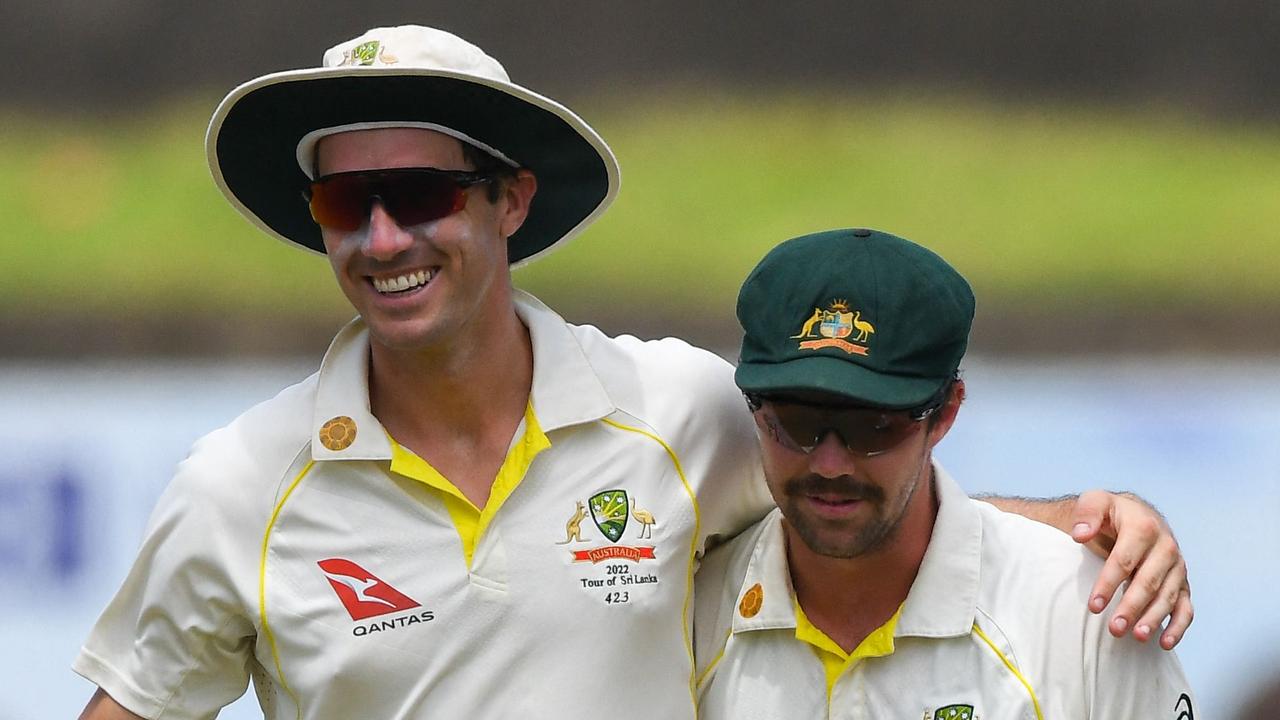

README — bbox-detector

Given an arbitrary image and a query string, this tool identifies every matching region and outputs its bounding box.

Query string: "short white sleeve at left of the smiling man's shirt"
[73,438,261,720]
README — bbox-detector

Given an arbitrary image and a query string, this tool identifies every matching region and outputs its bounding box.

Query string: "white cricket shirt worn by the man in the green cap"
[694,465,1192,720]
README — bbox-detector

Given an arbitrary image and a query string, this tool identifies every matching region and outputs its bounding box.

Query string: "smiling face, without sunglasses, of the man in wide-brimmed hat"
[316,128,532,351]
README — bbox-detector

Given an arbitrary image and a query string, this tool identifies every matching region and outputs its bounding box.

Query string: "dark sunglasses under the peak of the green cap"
[746,393,942,457]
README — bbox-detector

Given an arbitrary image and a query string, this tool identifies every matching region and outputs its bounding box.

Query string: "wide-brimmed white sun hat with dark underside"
[205,26,620,265]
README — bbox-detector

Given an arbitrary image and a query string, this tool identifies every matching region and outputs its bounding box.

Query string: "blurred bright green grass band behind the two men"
[0,92,1280,340]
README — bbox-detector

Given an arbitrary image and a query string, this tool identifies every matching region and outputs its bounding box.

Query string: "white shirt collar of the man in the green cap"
[733,464,982,638]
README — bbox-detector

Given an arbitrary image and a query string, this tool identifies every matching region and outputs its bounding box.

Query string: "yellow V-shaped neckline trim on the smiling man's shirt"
[387,402,552,568]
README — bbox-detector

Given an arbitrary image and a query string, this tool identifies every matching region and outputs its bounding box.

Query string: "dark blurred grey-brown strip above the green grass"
[0,0,1280,118]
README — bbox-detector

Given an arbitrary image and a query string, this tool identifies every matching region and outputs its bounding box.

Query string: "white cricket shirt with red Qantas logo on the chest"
[74,293,771,720]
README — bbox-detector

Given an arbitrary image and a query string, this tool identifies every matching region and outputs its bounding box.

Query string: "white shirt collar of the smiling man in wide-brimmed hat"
[311,291,614,460]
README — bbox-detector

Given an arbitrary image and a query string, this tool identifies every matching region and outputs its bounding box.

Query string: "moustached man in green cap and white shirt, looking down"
[692,229,1193,720]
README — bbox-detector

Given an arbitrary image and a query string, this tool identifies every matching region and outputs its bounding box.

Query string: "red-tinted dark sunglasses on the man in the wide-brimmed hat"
[302,168,494,232]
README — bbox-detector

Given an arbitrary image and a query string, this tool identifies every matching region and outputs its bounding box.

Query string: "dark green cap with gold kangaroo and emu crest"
[735,229,974,409]
